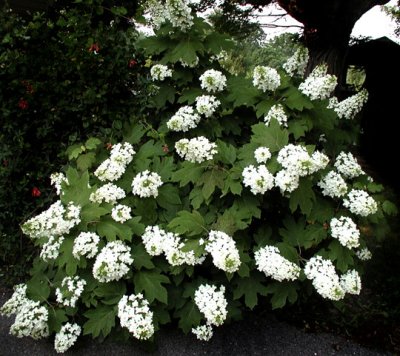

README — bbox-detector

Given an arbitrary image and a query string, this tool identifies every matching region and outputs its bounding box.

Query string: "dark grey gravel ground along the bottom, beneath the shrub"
[0,290,387,356]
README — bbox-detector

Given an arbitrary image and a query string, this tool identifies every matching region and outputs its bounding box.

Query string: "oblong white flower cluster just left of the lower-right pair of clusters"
[254,246,300,282]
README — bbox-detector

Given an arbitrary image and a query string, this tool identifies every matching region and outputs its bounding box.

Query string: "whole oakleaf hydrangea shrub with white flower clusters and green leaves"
[1,0,394,352]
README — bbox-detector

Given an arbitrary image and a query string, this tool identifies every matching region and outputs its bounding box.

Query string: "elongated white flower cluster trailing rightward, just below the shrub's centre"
[142,226,204,266]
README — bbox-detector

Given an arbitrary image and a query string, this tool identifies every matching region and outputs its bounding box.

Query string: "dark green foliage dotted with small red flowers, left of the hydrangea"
[0,0,147,281]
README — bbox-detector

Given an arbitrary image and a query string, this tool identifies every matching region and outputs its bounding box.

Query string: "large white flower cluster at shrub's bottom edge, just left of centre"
[118,293,154,340]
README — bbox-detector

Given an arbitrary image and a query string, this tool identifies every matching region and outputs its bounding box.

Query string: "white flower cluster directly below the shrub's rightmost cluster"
[330,216,360,249]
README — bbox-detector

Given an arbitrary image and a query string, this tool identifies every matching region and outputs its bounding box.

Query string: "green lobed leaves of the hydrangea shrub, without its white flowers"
[2,4,396,350]
